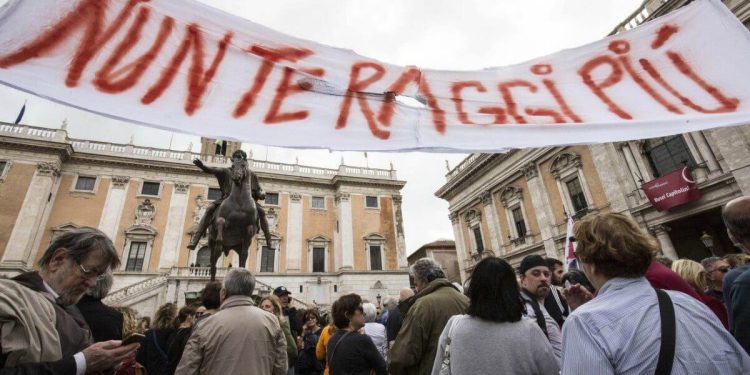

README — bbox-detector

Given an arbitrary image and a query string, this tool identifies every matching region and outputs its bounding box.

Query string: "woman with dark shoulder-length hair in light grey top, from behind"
[432,257,560,375]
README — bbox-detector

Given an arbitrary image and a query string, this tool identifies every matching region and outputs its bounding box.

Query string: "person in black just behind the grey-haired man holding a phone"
[76,272,123,342]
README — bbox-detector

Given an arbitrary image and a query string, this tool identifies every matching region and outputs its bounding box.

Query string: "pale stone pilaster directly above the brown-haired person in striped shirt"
[589,143,635,212]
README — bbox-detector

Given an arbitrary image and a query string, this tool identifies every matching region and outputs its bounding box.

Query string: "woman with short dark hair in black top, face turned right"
[326,293,388,375]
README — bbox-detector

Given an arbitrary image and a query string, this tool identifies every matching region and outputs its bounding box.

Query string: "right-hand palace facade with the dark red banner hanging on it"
[435,0,750,280]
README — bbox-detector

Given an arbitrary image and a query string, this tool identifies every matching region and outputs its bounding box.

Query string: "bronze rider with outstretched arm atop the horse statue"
[187,150,271,250]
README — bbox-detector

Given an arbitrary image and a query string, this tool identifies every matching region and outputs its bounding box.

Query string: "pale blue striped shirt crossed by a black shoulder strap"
[561,277,750,374]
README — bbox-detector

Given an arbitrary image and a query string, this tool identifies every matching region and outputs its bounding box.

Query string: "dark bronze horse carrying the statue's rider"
[208,159,258,281]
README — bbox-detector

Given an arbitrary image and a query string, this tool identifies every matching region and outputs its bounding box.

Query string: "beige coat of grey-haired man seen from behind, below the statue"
[176,296,288,375]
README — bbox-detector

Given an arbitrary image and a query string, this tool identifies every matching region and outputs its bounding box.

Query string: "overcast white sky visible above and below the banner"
[0,0,641,253]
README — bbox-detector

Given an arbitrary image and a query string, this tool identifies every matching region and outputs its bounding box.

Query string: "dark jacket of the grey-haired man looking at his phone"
[0,272,92,375]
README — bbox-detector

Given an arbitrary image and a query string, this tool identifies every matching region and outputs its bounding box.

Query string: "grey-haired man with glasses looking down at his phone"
[0,227,138,374]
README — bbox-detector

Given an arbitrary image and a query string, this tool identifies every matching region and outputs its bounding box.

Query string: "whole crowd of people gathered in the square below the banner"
[0,197,750,375]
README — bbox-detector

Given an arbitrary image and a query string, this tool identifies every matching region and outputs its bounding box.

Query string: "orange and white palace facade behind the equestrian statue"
[0,123,409,315]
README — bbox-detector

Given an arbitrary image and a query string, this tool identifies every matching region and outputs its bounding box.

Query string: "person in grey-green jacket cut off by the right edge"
[721,196,750,354]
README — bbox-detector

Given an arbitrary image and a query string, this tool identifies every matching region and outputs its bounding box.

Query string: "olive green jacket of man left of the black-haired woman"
[388,279,469,375]
